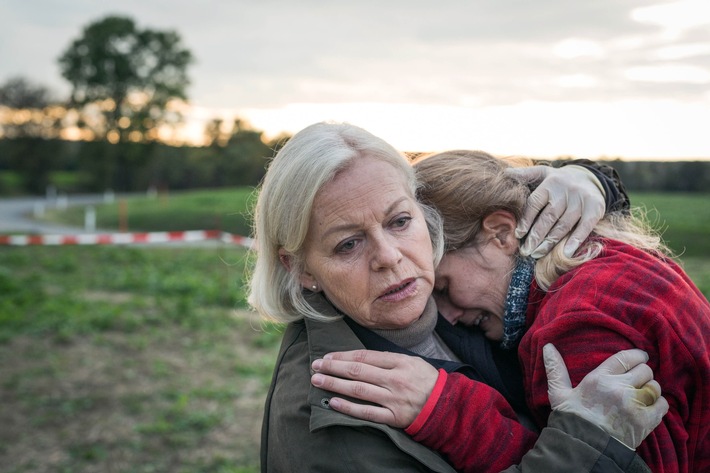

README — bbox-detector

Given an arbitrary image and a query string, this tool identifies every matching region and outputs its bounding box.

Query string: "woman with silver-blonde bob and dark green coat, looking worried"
[249,124,663,472]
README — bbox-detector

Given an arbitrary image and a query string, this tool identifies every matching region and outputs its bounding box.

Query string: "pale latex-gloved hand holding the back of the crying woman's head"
[506,165,606,259]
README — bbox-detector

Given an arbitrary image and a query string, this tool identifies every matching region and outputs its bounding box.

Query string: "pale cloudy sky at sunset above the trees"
[0,0,710,159]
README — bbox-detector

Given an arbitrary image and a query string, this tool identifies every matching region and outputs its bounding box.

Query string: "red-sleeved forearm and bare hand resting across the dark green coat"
[311,350,537,473]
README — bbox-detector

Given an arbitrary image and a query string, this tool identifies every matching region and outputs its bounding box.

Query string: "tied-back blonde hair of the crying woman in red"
[413,150,672,290]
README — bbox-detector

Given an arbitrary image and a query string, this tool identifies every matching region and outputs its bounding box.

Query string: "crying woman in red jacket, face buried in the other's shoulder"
[320,151,710,472]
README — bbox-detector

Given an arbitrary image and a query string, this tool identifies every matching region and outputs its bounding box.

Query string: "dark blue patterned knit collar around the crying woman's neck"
[500,255,535,349]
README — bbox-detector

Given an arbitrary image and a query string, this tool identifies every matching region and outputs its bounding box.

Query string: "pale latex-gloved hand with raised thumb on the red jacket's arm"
[543,343,668,450]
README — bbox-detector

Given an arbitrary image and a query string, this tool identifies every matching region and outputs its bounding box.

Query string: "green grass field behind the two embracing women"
[0,189,710,473]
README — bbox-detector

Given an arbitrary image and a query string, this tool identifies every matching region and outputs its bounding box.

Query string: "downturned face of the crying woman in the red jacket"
[434,241,513,340]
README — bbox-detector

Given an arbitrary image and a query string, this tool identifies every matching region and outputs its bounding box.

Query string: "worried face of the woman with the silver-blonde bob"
[301,158,434,329]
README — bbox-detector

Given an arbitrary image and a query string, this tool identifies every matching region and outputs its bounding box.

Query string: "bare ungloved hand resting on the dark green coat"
[311,350,439,428]
